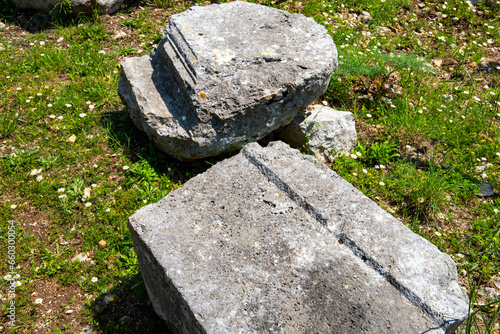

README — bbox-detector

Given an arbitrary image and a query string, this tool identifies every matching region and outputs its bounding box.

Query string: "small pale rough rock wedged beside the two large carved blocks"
[280,105,358,162]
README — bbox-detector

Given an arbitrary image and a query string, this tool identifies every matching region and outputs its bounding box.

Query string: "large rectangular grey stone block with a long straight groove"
[129,142,468,334]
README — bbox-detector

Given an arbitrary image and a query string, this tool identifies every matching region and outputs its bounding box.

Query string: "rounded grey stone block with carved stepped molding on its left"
[118,1,337,160]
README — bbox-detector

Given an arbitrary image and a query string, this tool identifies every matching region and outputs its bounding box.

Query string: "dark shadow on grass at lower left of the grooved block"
[90,273,172,334]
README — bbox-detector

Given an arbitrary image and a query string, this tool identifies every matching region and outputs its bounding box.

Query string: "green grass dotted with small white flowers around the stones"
[0,0,500,333]
